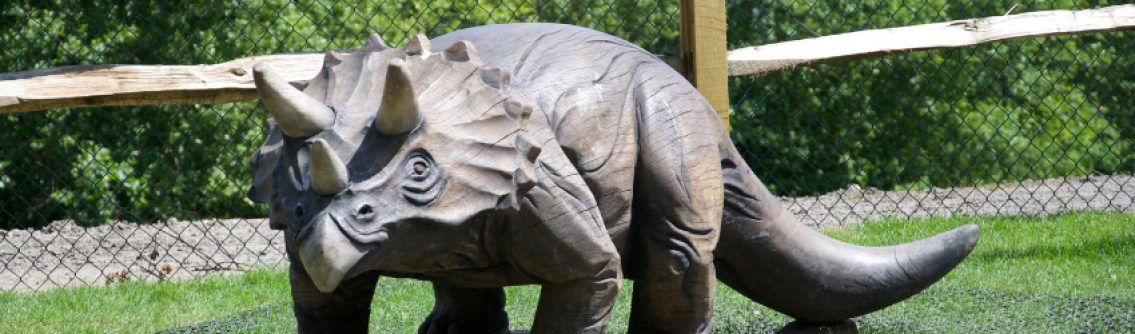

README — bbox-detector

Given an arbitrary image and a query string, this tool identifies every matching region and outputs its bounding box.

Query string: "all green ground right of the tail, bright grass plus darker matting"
[827,212,1135,333]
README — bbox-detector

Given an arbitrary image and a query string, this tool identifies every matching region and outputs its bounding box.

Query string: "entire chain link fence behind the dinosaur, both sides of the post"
[0,0,1135,291]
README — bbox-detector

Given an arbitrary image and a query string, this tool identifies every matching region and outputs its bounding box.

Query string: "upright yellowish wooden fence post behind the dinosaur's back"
[681,0,729,128]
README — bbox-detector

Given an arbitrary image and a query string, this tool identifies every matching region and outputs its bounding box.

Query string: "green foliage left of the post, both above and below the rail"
[0,0,678,228]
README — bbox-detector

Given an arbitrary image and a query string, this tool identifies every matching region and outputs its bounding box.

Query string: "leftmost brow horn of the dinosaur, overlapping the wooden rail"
[252,64,335,137]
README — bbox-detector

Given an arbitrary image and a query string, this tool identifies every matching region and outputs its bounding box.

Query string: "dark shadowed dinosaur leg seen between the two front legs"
[418,283,508,334]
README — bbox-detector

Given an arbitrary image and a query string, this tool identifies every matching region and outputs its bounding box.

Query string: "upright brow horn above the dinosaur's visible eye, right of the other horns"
[375,59,422,135]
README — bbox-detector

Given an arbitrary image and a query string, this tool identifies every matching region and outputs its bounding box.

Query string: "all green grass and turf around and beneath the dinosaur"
[0,214,1135,334]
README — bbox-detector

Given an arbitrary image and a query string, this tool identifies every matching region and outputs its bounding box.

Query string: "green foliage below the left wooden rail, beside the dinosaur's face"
[0,103,262,226]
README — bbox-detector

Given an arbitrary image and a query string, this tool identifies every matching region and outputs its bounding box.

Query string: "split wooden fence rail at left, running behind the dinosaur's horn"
[0,52,323,115]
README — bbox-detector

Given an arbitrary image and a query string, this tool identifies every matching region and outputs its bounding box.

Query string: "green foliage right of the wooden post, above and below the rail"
[729,0,1135,195]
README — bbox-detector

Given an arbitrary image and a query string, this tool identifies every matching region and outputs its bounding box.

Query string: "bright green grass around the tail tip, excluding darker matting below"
[827,212,1135,298]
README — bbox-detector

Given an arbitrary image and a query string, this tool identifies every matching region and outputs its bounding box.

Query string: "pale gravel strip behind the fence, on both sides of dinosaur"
[0,175,1135,291]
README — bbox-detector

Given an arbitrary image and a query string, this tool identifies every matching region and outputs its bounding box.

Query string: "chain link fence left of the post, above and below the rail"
[0,0,679,291]
